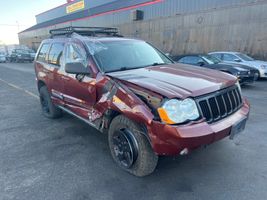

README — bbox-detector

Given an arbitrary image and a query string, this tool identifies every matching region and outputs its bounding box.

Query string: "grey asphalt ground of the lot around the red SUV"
[0,63,267,200]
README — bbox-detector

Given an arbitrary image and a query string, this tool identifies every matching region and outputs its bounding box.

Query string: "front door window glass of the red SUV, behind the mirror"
[66,43,87,67]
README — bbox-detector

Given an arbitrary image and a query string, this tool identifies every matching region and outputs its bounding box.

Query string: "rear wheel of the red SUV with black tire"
[39,86,62,119]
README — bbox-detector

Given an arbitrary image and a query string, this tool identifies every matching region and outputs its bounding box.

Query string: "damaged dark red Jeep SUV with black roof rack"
[34,27,249,176]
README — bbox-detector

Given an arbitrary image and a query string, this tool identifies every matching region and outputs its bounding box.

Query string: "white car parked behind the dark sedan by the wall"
[209,51,267,78]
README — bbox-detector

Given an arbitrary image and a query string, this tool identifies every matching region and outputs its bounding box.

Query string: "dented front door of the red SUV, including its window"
[62,39,96,119]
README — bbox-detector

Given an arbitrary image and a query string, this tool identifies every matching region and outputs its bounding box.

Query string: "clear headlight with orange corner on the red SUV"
[158,99,199,124]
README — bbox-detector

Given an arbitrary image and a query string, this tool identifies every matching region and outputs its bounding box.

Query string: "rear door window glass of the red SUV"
[48,43,64,66]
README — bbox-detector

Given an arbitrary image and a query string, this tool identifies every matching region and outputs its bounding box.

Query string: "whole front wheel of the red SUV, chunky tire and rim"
[108,115,158,177]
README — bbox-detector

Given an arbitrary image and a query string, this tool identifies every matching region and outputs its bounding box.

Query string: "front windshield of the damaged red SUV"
[87,40,172,72]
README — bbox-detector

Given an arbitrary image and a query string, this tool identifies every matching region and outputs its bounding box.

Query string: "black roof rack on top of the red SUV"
[49,26,122,37]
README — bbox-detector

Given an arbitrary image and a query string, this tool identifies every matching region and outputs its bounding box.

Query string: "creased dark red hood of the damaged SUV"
[108,64,236,99]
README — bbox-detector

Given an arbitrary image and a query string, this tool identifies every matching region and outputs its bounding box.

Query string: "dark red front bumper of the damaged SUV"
[147,100,249,155]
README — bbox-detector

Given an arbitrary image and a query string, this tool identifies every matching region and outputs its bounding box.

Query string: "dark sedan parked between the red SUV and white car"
[173,54,259,84]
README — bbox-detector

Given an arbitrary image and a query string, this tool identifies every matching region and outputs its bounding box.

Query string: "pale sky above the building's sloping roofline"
[0,0,66,44]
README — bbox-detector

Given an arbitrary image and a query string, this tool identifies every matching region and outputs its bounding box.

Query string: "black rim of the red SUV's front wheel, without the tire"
[113,129,138,169]
